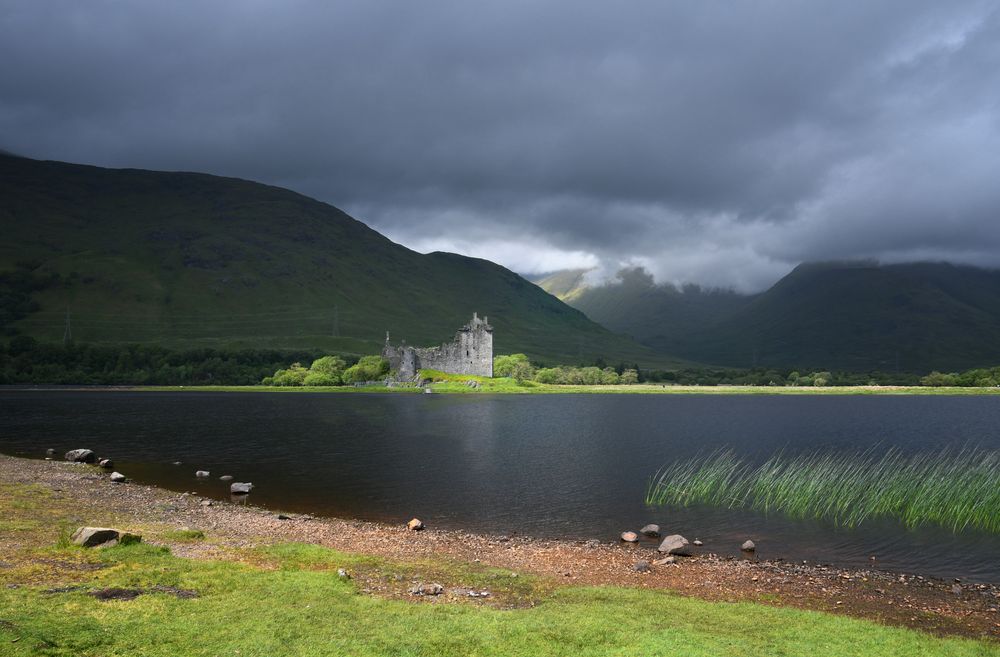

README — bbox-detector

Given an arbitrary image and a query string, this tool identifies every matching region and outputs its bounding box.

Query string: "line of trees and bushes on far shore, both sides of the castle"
[0,335,1000,387]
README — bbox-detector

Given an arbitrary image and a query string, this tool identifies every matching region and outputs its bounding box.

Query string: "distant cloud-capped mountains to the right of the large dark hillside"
[540,262,1000,372]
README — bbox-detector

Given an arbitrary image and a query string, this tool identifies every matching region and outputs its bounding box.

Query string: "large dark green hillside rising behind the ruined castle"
[0,156,671,366]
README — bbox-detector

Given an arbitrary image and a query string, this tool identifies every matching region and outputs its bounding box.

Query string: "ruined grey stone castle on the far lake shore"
[382,313,493,381]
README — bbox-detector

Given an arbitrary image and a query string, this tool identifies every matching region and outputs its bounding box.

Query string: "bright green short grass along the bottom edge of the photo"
[0,545,1000,657]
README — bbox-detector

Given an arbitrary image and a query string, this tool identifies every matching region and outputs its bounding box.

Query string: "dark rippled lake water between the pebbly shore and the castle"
[0,390,1000,583]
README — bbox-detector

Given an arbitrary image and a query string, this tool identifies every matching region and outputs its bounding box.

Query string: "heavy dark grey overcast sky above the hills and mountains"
[0,0,1000,291]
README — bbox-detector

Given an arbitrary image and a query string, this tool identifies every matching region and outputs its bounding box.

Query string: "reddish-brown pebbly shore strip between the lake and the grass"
[0,456,1000,640]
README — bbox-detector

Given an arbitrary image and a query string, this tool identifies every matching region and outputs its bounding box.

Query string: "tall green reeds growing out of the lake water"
[646,449,1000,533]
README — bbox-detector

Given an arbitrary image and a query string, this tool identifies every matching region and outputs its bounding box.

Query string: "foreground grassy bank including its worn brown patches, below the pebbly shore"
[0,464,1000,657]
